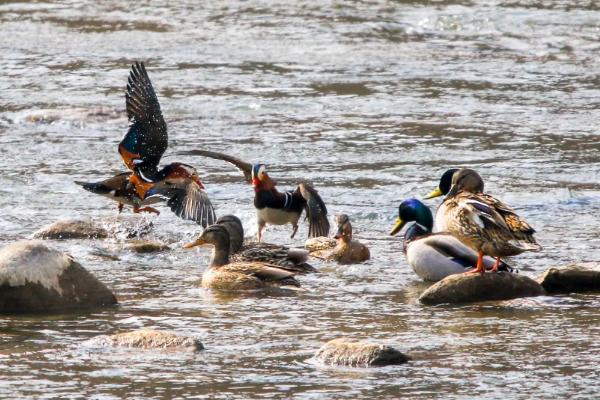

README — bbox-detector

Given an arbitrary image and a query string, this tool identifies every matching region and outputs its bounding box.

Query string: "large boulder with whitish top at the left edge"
[0,240,117,313]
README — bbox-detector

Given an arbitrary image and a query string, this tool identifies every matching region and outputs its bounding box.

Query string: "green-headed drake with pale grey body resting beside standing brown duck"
[390,198,513,282]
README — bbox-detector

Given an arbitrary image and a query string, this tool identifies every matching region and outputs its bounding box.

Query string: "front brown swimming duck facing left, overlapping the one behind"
[184,225,300,291]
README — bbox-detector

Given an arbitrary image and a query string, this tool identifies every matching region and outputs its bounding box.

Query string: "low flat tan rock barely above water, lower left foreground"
[89,329,204,352]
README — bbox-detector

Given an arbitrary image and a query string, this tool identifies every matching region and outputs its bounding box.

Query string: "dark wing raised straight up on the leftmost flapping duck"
[119,62,168,175]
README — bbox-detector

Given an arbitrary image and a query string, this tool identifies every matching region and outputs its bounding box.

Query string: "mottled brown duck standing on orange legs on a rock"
[422,168,542,273]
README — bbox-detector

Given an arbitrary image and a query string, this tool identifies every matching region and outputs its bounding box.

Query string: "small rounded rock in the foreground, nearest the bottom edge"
[315,339,410,367]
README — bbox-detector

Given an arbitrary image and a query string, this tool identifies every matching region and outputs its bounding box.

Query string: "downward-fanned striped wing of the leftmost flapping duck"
[163,182,217,228]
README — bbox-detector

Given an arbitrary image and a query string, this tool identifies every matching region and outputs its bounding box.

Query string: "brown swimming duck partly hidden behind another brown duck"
[216,214,317,274]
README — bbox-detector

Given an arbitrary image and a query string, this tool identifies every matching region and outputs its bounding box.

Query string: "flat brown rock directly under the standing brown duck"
[419,272,545,304]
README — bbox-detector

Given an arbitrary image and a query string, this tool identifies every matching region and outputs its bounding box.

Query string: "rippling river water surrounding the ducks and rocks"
[0,0,600,399]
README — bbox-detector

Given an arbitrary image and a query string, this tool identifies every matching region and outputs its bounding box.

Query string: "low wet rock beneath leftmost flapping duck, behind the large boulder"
[33,215,152,239]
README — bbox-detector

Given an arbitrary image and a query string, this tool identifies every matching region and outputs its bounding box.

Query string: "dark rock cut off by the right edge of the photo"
[537,263,600,293]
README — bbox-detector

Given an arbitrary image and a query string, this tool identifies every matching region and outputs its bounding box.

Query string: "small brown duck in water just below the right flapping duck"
[310,214,371,264]
